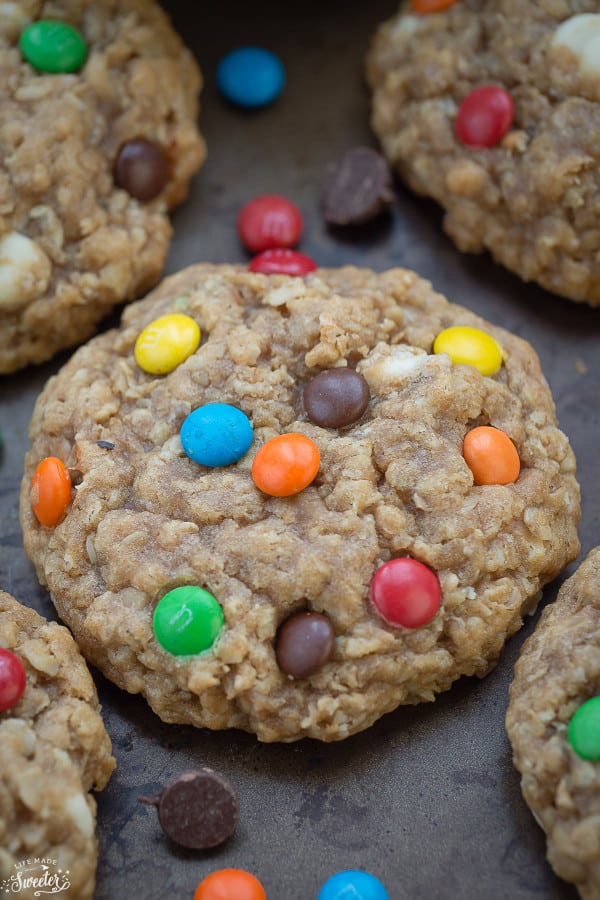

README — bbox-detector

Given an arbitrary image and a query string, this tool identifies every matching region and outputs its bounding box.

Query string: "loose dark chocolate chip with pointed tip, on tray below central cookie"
[139,768,239,850]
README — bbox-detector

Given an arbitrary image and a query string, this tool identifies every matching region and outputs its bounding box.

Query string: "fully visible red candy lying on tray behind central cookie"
[237,194,303,253]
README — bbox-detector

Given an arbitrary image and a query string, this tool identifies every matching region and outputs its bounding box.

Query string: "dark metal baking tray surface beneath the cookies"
[0,0,600,900]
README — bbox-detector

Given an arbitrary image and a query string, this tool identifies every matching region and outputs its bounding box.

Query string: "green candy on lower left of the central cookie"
[152,585,224,656]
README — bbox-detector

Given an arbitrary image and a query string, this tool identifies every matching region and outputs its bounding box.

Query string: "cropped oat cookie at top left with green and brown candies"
[0,0,205,372]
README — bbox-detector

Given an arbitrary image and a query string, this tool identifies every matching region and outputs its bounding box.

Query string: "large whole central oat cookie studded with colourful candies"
[21,265,579,741]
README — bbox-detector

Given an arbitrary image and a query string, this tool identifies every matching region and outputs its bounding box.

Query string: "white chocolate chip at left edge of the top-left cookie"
[0,231,52,310]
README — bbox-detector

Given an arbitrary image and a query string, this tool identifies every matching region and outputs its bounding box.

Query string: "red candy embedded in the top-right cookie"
[454,84,514,147]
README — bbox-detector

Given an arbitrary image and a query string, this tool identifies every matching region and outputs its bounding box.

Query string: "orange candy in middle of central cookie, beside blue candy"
[252,432,321,497]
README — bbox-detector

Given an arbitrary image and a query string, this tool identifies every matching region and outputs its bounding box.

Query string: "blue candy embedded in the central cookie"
[179,403,254,467]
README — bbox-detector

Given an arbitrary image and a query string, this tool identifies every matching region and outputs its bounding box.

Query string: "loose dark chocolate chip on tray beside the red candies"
[323,147,394,225]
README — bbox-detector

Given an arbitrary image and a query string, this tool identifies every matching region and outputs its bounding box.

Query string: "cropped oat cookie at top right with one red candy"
[367,0,600,304]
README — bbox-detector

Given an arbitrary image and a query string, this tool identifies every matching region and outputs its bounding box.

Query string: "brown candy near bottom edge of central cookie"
[275,612,335,678]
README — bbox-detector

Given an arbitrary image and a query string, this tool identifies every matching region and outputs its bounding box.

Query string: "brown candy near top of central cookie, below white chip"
[302,368,370,428]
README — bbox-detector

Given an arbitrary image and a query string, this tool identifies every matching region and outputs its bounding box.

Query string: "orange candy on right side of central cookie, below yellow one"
[463,425,521,484]
